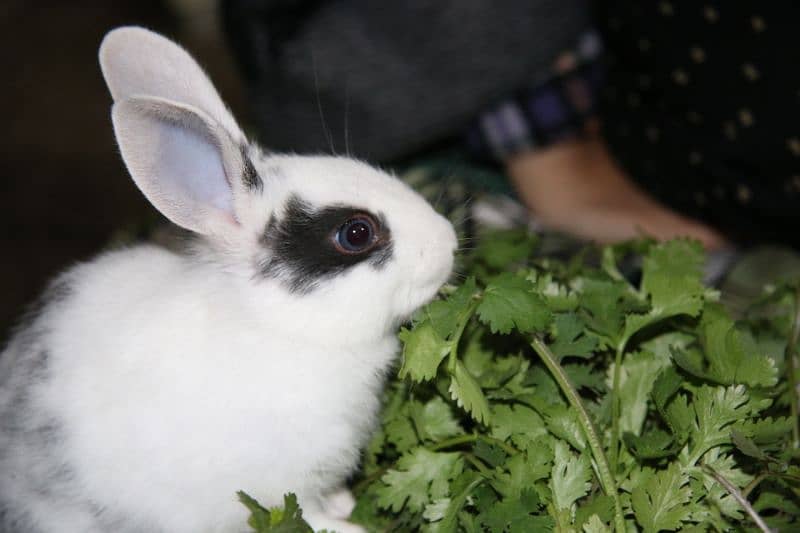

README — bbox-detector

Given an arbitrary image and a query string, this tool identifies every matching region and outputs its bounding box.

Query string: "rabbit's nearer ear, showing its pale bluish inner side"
[112,98,241,234]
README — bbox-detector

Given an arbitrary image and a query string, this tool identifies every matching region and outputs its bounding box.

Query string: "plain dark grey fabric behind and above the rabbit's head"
[222,0,588,161]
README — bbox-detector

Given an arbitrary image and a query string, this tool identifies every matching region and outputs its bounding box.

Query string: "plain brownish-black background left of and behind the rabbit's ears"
[0,0,242,338]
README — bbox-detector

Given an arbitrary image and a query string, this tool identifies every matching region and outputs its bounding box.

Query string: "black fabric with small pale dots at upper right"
[597,0,800,247]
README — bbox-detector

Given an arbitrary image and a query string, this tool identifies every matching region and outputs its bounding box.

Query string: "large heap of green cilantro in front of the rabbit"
[245,231,800,533]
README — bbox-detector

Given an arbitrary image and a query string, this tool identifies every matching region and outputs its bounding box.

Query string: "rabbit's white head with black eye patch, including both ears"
[100,27,456,340]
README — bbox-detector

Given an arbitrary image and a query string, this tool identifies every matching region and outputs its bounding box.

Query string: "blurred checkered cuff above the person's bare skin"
[467,31,603,161]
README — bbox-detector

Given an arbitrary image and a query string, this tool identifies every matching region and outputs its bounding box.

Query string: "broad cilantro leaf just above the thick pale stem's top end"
[477,273,550,334]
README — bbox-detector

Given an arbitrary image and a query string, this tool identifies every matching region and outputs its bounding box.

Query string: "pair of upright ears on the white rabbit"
[100,27,262,237]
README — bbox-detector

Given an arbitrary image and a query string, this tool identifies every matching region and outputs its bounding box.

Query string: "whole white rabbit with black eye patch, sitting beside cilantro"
[0,27,456,533]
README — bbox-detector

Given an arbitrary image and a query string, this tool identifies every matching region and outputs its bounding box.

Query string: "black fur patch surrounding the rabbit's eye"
[261,196,393,293]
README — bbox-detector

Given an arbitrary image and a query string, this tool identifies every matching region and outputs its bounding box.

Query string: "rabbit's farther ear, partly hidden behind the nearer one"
[99,26,244,142]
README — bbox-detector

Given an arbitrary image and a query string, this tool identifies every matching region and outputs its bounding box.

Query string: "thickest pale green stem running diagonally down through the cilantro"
[531,336,626,533]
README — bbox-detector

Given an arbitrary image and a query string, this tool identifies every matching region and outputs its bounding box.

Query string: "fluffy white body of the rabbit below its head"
[0,246,396,532]
